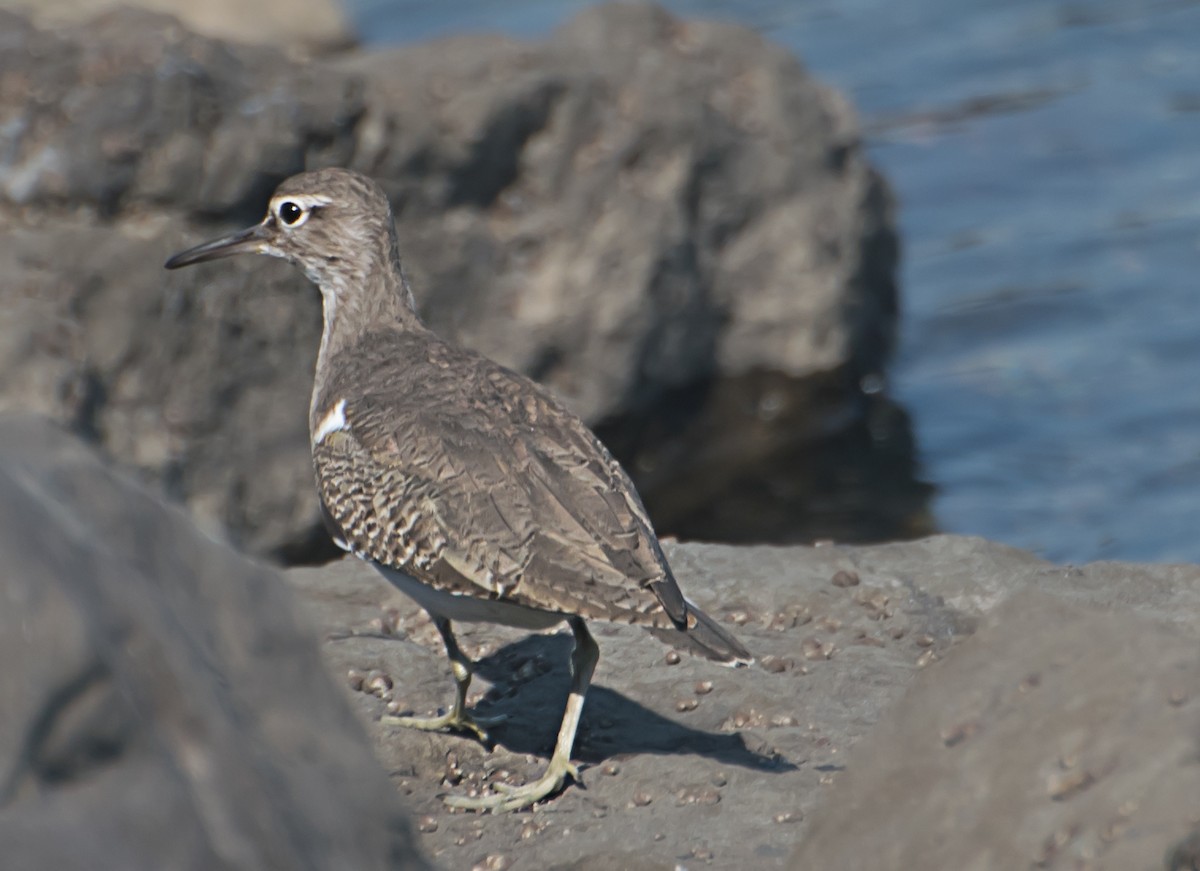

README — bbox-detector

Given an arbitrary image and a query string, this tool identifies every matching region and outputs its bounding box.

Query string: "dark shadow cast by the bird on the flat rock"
[475,635,797,773]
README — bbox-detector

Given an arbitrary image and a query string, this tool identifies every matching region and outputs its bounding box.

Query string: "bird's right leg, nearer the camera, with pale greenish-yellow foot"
[443,617,600,813]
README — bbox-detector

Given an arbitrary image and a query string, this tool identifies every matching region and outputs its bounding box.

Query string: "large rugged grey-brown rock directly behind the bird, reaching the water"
[0,5,902,560]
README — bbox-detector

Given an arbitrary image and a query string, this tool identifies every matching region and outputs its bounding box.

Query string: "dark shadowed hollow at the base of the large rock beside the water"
[596,372,932,543]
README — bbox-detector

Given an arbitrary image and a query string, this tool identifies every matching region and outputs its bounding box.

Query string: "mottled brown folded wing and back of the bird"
[313,346,688,627]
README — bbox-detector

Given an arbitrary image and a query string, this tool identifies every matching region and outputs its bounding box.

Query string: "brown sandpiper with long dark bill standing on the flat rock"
[164,168,754,812]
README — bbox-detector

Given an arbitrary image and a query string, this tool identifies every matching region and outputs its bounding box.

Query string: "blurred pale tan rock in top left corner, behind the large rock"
[0,0,356,54]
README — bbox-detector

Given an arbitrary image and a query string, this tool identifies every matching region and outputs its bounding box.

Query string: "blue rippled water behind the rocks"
[352,0,1200,563]
